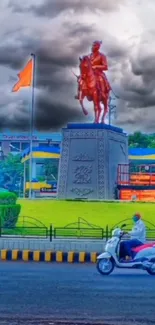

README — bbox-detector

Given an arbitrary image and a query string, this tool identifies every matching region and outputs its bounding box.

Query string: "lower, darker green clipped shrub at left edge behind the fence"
[0,204,21,228]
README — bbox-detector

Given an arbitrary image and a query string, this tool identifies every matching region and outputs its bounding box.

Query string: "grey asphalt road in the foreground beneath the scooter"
[0,262,155,325]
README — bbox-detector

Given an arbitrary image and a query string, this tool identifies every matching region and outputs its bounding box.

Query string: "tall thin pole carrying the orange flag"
[29,53,36,200]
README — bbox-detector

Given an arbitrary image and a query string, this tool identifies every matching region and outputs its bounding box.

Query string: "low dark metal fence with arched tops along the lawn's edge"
[0,217,155,241]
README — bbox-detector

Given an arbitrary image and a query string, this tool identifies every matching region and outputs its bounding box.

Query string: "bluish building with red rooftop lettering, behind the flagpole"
[0,131,61,156]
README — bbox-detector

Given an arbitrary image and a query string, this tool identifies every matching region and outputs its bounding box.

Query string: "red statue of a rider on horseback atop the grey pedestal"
[75,41,112,123]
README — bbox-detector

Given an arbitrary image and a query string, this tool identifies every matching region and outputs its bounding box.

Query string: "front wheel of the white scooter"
[96,258,115,275]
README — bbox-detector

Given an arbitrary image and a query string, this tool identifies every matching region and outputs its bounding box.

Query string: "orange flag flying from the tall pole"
[12,59,33,92]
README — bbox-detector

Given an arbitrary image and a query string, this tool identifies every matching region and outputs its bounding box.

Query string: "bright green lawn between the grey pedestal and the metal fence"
[18,200,155,228]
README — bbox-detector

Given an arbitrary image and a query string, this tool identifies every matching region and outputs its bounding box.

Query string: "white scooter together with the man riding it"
[96,213,155,276]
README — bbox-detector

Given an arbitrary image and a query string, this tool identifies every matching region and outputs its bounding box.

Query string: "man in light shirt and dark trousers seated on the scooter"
[121,213,146,261]
